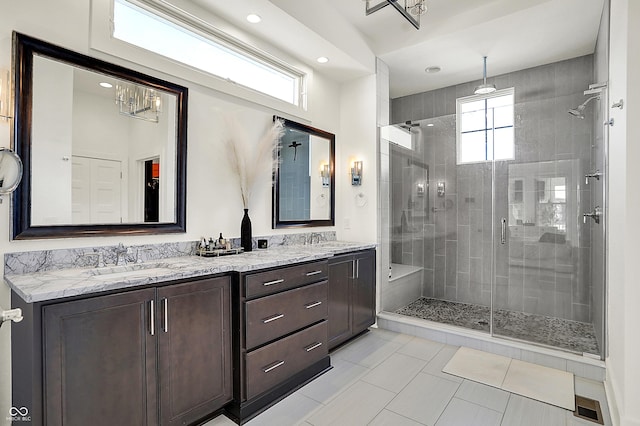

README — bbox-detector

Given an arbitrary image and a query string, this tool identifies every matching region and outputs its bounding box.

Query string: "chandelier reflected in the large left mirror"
[116,84,162,123]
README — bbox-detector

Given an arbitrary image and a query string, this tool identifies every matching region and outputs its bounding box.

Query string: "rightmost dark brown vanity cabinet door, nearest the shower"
[351,250,376,334]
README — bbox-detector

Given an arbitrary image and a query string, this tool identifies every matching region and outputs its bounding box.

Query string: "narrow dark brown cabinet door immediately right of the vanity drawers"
[327,256,353,348]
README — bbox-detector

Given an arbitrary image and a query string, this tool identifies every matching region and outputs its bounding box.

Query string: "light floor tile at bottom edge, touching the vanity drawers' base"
[246,393,322,426]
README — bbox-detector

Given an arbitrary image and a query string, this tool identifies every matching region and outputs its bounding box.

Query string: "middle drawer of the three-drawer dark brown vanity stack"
[245,280,328,349]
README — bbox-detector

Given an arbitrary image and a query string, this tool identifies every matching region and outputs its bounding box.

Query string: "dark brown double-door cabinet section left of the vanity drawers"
[14,277,232,426]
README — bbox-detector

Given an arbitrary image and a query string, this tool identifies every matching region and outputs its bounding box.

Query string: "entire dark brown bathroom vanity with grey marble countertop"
[5,242,375,425]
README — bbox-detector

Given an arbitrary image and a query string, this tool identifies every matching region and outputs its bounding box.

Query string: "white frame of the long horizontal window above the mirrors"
[90,0,313,119]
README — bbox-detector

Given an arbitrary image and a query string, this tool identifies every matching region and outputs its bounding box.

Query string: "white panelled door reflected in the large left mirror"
[71,155,122,224]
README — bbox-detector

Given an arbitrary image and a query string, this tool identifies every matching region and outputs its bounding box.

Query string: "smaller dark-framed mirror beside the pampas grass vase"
[273,117,336,228]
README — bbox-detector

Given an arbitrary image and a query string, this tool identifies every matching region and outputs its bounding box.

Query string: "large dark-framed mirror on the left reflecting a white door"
[12,32,188,239]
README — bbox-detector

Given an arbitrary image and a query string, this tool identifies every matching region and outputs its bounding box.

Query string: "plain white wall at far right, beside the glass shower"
[606,0,640,426]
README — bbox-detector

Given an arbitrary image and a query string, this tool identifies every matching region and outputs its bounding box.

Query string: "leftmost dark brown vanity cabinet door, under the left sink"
[43,289,158,426]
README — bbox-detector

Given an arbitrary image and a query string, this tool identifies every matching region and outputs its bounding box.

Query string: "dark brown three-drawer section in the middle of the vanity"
[227,260,330,423]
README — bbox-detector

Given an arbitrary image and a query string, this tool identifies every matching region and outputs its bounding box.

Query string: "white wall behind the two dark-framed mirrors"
[0,0,377,425]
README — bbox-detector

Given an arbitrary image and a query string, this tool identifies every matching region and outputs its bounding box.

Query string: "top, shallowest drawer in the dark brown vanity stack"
[245,260,328,299]
